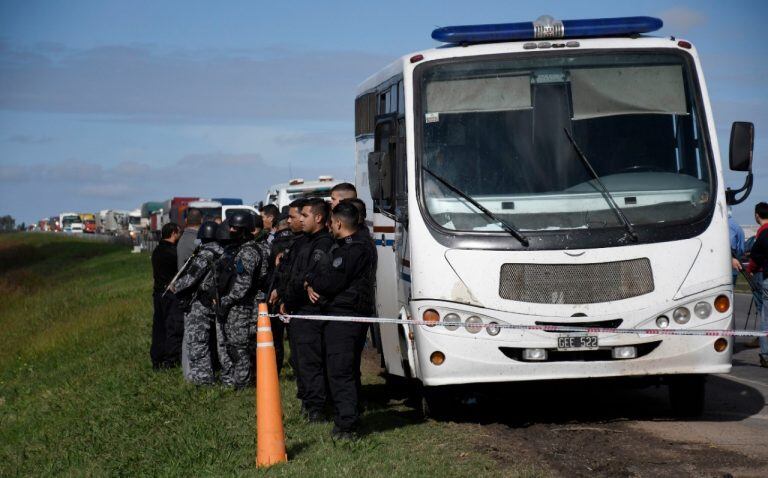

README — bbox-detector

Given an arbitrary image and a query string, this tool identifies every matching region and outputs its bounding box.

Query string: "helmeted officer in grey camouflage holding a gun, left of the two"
[173,221,224,385]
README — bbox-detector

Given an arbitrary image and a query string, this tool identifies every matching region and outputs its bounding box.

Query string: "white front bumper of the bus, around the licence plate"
[410,301,733,386]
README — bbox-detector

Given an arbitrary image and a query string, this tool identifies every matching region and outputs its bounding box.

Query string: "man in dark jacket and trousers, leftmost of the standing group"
[149,222,184,370]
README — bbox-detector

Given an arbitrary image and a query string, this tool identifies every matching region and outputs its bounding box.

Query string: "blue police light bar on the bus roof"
[432,15,664,44]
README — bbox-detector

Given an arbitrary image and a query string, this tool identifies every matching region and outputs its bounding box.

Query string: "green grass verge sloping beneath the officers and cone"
[0,234,535,477]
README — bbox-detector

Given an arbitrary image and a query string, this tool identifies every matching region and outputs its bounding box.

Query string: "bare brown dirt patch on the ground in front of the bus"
[468,423,768,477]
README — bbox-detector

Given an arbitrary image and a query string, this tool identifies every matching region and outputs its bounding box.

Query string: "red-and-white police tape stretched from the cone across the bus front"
[269,314,768,337]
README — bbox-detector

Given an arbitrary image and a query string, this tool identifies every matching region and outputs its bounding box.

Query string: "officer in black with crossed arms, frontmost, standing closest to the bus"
[308,202,375,439]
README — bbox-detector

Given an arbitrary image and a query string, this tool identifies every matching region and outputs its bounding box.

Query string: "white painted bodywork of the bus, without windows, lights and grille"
[355,38,733,386]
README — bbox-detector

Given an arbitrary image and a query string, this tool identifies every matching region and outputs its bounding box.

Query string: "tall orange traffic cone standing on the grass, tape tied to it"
[256,302,288,467]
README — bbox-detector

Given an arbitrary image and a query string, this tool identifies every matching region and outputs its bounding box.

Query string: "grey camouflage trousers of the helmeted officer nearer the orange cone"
[217,305,256,388]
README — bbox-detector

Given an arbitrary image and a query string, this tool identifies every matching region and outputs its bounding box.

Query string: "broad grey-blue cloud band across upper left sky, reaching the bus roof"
[0,45,391,120]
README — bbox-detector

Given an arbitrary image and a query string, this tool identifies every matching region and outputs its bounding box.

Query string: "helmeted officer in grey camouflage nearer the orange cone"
[219,212,268,388]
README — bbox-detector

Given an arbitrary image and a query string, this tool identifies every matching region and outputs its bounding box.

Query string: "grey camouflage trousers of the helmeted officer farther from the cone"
[182,301,216,385]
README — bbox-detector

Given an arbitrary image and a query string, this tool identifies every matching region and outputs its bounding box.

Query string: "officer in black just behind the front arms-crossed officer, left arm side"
[282,198,333,421]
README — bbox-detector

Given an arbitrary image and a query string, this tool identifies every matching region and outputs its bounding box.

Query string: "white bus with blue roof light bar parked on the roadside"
[355,17,754,415]
